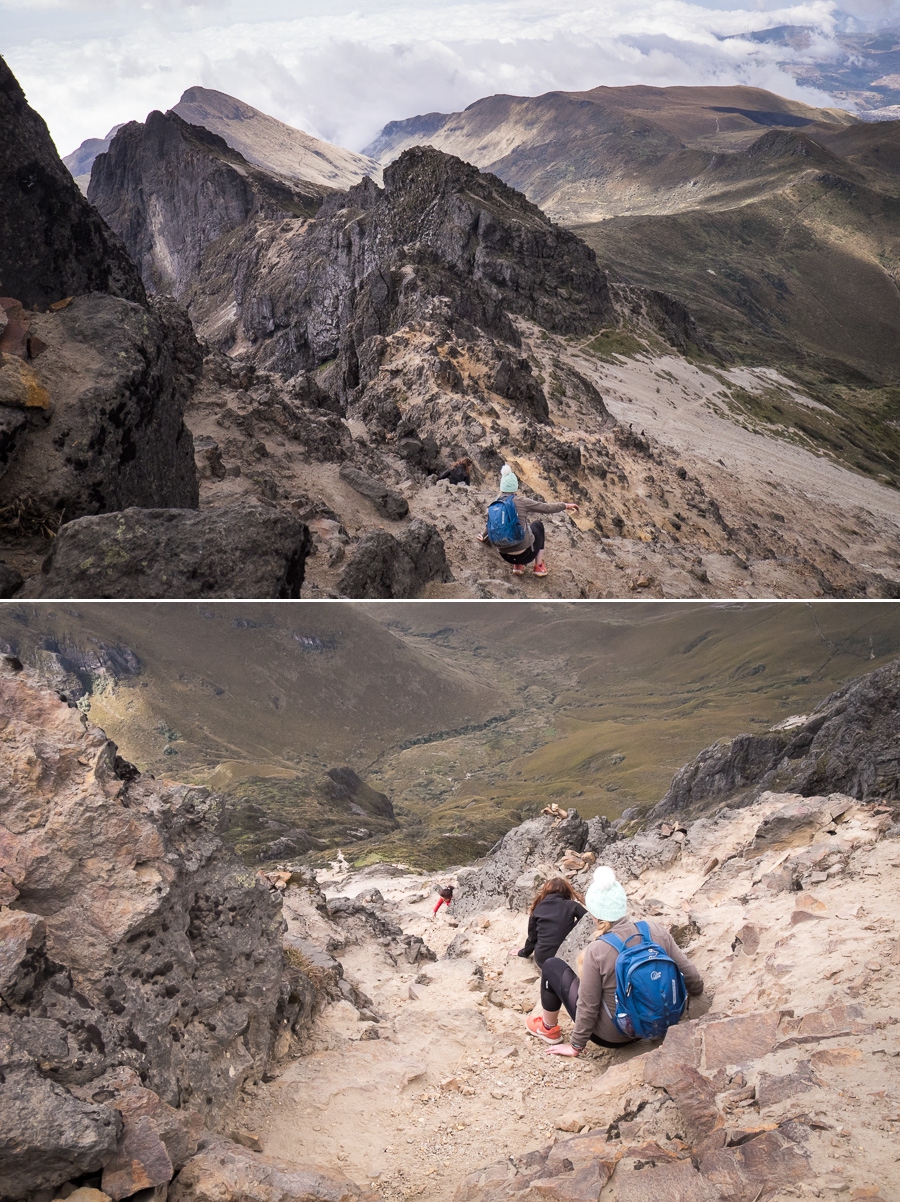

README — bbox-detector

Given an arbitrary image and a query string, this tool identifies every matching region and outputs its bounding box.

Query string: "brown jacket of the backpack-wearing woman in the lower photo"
[571,918,703,1048]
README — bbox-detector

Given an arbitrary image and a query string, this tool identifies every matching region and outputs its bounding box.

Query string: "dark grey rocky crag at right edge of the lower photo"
[650,660,900,817]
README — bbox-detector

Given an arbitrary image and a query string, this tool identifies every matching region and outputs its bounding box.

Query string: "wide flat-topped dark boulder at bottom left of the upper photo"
[26,506,310,599]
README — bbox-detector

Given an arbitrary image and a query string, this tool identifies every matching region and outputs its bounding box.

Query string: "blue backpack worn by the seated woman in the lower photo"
[600,922,687,1040]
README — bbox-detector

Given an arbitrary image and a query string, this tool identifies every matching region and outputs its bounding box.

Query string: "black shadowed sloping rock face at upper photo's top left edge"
[0,59,145,308]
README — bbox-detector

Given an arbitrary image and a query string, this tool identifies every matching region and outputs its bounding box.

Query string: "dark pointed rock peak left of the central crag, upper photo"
[88,112,328,301]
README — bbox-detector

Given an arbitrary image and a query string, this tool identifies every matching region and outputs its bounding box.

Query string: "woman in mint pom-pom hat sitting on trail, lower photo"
[526,864,703,1055]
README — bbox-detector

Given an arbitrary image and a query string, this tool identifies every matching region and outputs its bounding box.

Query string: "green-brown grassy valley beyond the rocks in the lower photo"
[0,602,900,869]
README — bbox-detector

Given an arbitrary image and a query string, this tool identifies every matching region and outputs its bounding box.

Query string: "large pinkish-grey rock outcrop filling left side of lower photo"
[0,660,310,1198]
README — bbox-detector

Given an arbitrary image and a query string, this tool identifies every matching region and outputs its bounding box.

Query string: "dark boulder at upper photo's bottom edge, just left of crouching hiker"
[338,518,452,599]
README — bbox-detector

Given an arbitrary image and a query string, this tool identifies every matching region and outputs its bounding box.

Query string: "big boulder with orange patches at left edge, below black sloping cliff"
[0,293,201,519]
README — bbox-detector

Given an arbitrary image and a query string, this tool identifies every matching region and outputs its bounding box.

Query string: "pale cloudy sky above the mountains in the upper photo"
[0,0,900,154]
